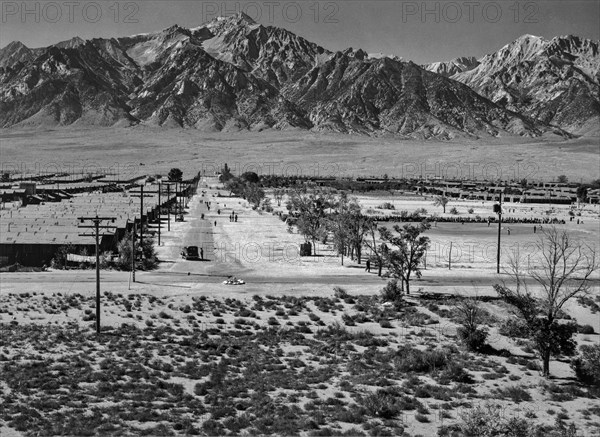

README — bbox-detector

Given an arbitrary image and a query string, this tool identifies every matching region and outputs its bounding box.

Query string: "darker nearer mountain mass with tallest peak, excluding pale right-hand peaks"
[0,14,584,139]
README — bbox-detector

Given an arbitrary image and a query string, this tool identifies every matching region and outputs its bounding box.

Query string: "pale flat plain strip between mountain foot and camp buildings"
[0,126,600,182]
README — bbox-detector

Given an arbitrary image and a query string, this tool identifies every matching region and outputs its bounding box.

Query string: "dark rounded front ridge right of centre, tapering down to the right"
[284,52,540,139]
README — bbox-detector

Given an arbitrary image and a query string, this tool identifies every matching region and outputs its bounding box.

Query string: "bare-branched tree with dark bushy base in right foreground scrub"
[494,227,598,377]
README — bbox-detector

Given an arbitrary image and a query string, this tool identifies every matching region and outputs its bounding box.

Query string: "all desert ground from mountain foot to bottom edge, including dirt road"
[0,127,600,436]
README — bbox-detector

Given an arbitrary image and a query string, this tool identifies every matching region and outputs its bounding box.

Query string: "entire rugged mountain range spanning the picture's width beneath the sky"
[0,14,600,140]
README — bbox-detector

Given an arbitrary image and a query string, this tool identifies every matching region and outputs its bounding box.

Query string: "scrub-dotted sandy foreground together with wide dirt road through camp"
[0,178,600,436]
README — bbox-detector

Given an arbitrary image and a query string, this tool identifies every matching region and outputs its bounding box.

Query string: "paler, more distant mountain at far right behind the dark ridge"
[452,35,600,135]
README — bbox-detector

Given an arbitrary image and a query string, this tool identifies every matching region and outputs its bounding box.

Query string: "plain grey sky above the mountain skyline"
[0,0,600,63]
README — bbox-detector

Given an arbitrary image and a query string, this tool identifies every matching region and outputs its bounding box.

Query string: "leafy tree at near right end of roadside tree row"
[379,221,431,294]
